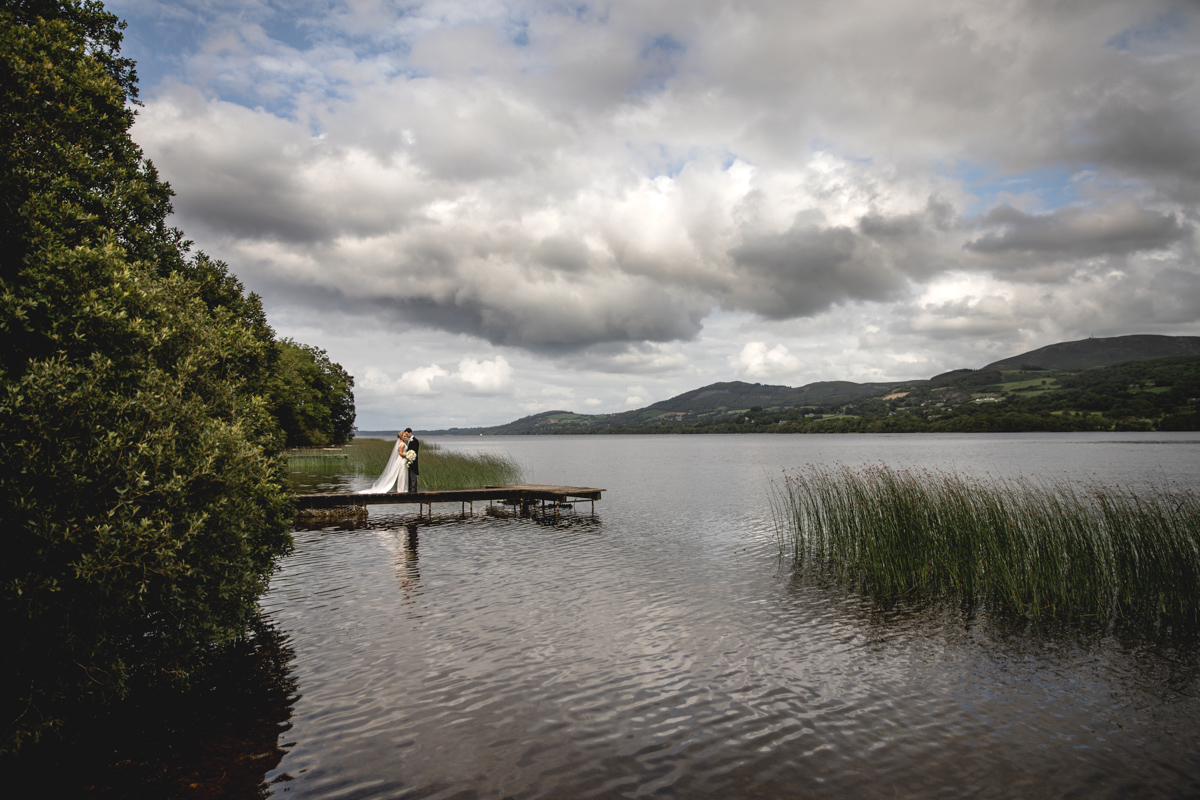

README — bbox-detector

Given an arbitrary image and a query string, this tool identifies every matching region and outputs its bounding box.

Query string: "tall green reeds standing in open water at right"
[772,465,1200,625]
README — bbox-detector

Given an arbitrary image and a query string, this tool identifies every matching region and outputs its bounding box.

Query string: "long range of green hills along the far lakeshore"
[431,336,1200,434]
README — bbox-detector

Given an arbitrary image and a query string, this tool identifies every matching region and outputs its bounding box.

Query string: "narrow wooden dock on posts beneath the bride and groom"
[295,485,604,516]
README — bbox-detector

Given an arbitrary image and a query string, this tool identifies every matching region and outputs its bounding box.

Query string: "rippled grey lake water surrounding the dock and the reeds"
[262,434,1200,799]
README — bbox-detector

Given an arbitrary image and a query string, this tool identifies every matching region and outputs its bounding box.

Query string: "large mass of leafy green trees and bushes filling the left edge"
[0,2,292,752]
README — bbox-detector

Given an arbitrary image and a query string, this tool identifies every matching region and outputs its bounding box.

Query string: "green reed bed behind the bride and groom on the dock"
[289,439,522,492]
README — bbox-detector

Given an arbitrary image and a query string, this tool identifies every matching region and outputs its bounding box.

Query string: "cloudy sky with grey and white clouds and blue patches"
[108,0,1200,429]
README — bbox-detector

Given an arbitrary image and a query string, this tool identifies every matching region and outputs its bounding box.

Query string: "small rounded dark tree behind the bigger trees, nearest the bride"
[271,339,354,447]
